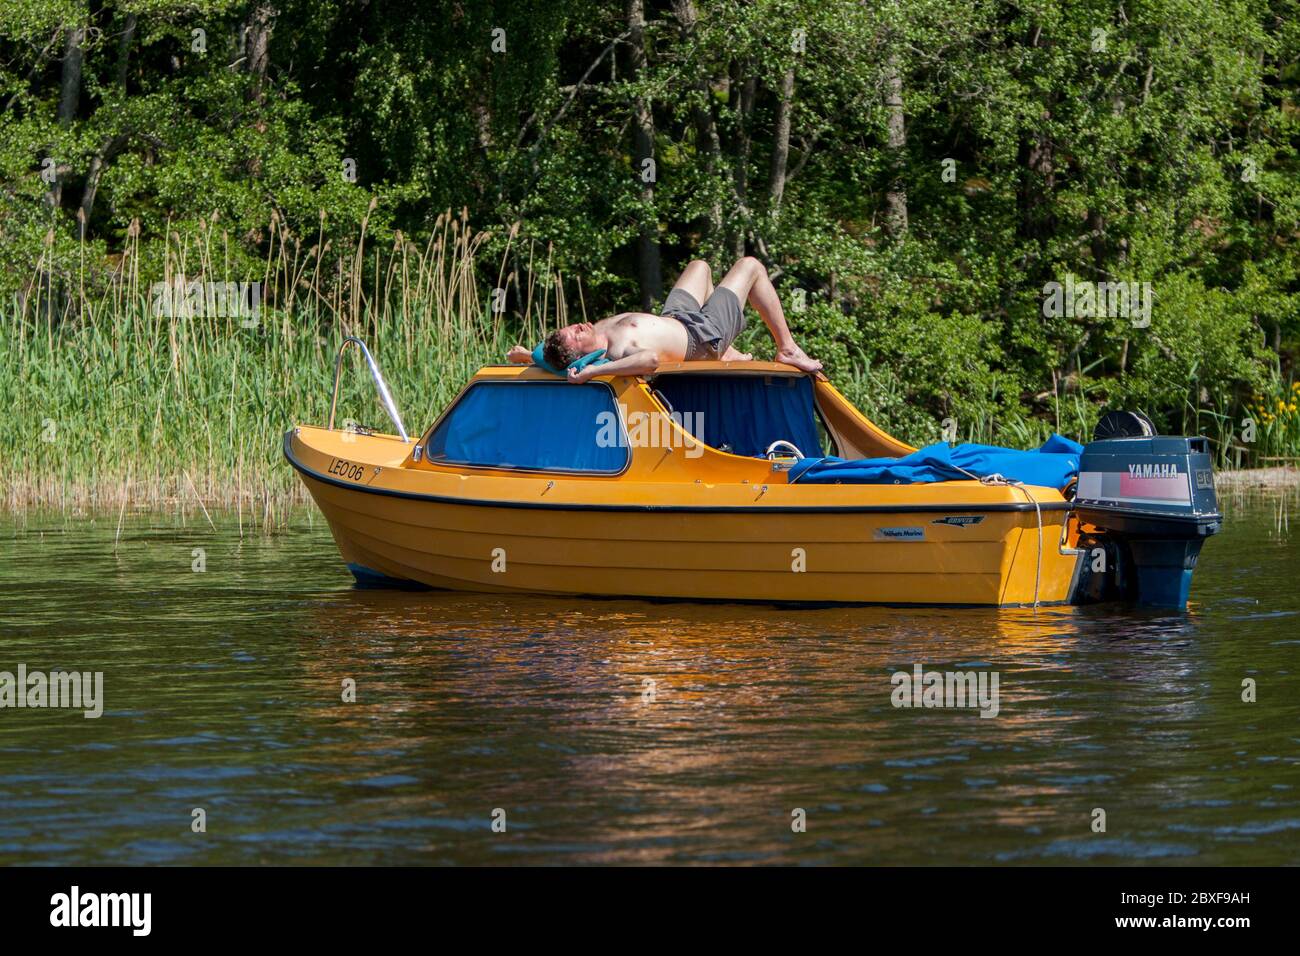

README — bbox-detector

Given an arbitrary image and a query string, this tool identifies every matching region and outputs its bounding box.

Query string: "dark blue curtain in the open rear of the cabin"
[654,372,822,458]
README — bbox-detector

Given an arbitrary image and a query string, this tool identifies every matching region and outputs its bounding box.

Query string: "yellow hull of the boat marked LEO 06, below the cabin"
[286,442,1078,606]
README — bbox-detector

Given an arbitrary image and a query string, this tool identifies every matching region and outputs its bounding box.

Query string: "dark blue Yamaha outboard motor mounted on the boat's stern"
[1075,412,1223,609]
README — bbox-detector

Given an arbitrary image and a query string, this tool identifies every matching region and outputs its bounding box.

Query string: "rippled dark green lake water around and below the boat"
[0,501,1300,865]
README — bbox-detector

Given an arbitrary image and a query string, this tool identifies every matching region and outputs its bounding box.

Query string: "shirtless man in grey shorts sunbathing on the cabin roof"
[506,256,822,384]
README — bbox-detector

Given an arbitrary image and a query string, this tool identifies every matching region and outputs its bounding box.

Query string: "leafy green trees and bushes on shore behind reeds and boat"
[0,0,1300,441]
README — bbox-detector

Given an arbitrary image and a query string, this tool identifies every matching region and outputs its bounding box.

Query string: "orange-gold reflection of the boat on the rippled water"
[289,589,1200,774]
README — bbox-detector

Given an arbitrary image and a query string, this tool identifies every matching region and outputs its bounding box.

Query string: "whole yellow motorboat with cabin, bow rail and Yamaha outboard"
[283,339,1221,606]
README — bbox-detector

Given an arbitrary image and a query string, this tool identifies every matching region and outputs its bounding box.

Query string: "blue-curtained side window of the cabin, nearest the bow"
[425,381,628,475]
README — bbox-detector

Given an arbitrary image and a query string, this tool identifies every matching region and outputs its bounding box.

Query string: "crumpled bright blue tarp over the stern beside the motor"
[790,434,1083,488]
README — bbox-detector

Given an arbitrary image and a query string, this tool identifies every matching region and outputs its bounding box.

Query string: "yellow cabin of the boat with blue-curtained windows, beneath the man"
[413,362,915,481]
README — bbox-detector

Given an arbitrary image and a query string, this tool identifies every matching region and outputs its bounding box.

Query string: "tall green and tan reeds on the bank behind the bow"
[0,206,567,528]
